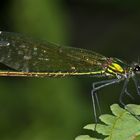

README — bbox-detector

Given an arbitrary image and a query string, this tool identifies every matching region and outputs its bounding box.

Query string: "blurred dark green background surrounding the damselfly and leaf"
[0,0,140,140]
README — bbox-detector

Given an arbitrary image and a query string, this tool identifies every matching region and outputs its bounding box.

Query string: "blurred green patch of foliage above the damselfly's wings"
[10,0,69,43]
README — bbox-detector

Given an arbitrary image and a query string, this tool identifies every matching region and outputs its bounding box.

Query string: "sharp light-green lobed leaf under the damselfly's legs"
[75,104,140,140]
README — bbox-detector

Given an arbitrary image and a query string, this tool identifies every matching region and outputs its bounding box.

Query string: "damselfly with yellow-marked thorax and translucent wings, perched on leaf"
[0,31,140,121]
